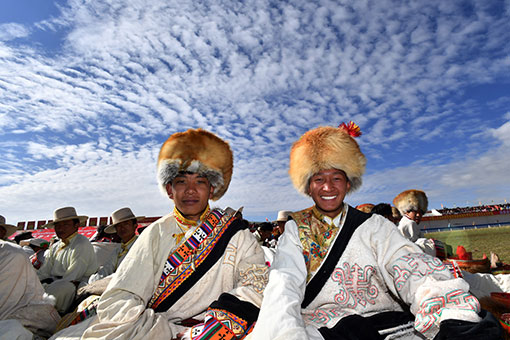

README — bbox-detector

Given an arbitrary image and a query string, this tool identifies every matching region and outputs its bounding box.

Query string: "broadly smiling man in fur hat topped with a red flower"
[251,123,501,340]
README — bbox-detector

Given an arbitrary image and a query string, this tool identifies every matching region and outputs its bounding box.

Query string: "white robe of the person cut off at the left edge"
[0,240,60,339]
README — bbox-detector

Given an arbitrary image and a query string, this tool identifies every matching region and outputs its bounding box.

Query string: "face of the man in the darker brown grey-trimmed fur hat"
[166,173,214,221]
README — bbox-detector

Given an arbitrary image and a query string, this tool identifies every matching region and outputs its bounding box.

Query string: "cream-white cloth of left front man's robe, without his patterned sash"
[52,214,267,340]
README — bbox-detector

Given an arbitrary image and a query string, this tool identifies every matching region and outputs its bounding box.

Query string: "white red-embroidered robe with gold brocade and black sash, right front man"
[250,204,486,340]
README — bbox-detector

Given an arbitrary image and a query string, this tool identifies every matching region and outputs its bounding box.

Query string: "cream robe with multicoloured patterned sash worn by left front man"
[52,209,268,340]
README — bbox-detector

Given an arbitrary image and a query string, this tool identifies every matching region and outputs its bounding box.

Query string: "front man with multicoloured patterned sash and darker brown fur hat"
[54,129,267,340]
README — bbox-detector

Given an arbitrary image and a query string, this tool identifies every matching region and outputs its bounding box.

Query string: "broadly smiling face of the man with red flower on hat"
[308,169,351,218]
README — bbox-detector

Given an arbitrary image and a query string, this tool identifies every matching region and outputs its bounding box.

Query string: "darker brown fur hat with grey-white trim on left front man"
[158,129,234,200]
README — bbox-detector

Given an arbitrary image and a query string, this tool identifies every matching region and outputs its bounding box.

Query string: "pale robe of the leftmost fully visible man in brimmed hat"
[37,233,98,313]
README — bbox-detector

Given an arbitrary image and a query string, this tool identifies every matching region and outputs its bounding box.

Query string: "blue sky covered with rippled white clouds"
[0,0,510,224]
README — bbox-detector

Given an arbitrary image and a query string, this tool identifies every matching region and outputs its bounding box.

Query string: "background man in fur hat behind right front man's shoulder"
[393,190,436,256]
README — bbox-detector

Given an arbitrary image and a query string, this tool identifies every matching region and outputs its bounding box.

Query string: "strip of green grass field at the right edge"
[425,226,510,263]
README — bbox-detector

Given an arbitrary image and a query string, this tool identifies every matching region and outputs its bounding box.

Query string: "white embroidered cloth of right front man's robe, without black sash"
[251,205,479,340]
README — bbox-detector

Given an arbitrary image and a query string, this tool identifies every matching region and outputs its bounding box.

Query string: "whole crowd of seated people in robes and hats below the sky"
[0,122,503,340]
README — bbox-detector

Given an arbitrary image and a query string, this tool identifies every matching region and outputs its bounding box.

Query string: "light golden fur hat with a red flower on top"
[289,122,367,195]
